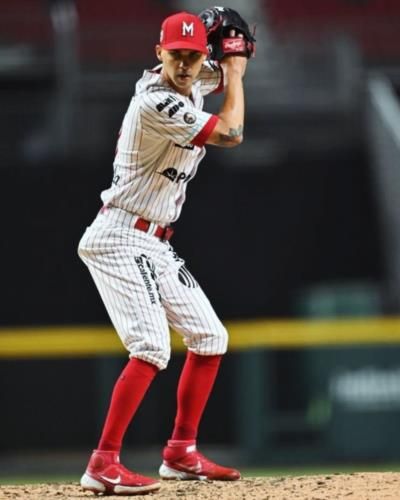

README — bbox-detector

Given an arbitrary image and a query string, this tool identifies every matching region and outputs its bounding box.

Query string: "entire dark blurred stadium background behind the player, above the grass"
[0,0,400,476]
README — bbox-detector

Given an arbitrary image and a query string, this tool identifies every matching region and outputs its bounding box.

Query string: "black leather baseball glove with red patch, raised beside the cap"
[199,7,256,61]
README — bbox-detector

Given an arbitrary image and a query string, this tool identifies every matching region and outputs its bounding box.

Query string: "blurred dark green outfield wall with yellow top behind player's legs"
[0,317,400,464]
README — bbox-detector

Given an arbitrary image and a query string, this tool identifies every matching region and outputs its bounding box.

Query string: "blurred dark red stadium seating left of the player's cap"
[0,0,170,65]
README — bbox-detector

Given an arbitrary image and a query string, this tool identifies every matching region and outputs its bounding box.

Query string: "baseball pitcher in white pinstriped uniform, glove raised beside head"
[79,7,254,495]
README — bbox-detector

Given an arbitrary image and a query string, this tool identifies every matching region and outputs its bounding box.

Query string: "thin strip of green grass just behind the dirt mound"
[0,464,400,486]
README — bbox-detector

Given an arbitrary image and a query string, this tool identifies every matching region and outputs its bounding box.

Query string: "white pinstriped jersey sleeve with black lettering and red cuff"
[140,91,218,147]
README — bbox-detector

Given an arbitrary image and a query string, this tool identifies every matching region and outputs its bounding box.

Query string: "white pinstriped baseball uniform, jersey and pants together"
[78,59,228,369]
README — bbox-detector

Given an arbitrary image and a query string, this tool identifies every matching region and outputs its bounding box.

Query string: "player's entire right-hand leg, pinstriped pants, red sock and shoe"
[159,249,240,481]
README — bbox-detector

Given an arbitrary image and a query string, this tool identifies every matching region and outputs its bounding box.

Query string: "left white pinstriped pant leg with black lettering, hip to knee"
[78,219,171,370]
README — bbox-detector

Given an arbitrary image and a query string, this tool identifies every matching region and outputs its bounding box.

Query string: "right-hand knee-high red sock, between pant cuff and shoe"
[172,351,222,440]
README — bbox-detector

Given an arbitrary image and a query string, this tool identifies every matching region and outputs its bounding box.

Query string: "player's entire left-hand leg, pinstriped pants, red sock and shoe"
[79,224,170,495]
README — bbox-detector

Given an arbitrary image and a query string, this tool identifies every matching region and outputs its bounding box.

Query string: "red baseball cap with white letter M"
[160,12,208,54]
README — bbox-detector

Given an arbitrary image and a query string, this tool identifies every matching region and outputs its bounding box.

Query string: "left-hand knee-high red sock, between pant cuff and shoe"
[98,358,158,451]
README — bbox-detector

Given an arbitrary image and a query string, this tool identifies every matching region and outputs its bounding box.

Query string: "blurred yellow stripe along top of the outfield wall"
[0,317,400,358]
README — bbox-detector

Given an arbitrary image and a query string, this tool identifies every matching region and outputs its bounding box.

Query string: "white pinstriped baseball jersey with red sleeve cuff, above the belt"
[101,62,222,225]
